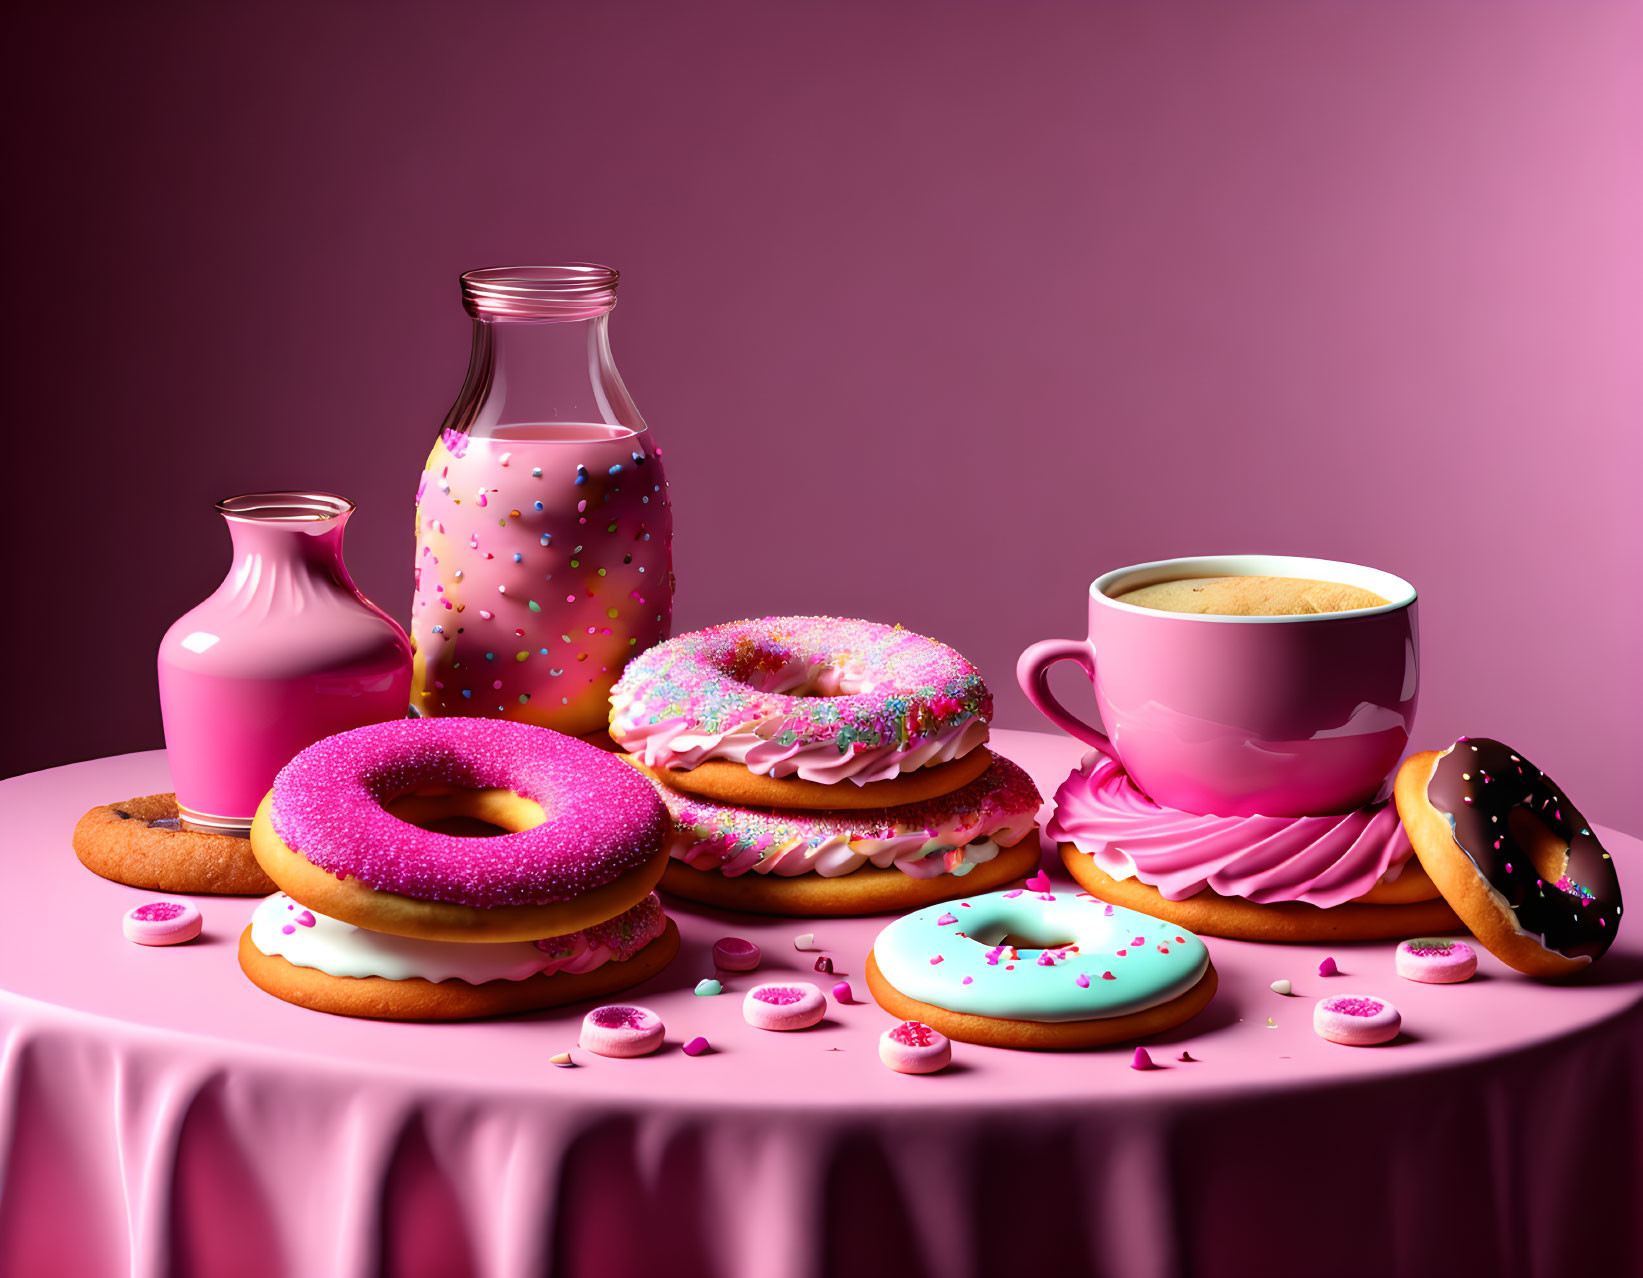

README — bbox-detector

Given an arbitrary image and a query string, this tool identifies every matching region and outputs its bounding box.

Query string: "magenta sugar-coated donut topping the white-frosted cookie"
[251,718,667,941]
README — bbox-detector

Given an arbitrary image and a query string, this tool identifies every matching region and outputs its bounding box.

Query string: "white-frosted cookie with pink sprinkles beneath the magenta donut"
[240,894,679,1020]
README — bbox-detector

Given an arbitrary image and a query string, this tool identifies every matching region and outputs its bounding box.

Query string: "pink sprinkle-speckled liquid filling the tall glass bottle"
[411,424,672,733]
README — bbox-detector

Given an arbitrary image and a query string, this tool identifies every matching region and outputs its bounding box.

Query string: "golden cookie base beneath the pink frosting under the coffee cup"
[1061,843,1462,941]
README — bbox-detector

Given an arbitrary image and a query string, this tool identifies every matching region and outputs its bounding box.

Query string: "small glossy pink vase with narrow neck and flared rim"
[159,493,411,831]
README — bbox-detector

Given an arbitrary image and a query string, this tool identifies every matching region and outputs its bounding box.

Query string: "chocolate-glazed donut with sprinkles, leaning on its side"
[1393,738,1623,977]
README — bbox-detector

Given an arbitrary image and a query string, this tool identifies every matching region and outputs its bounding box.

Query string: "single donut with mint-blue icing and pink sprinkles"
[866,880,1216,1050]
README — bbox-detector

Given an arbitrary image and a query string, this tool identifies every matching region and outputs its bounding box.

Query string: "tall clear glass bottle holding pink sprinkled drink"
[411,263,674,736]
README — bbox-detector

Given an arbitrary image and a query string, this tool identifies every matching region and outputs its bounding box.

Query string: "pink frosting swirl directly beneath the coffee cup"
[1045,751,1415,910]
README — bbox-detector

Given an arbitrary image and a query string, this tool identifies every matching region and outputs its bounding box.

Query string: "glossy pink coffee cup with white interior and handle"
[1015,555,1420,816]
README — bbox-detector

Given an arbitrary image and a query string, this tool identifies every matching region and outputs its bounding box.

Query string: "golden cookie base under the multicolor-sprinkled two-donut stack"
[660,834,1038,918]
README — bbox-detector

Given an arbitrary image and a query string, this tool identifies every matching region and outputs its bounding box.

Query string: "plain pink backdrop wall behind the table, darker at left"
[0,3,1643,830]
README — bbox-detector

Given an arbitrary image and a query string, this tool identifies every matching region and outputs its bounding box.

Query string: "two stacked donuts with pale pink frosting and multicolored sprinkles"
[610,616,1040,917]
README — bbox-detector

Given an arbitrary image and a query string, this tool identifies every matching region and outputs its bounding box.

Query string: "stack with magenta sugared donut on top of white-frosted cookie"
[240,718,679,1020]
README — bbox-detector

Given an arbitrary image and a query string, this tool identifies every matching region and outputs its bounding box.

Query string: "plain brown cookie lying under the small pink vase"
[72,793,274,897]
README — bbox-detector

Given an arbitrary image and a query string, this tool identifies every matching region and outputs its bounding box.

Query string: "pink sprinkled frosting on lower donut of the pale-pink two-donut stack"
[657,756,1042,879]
